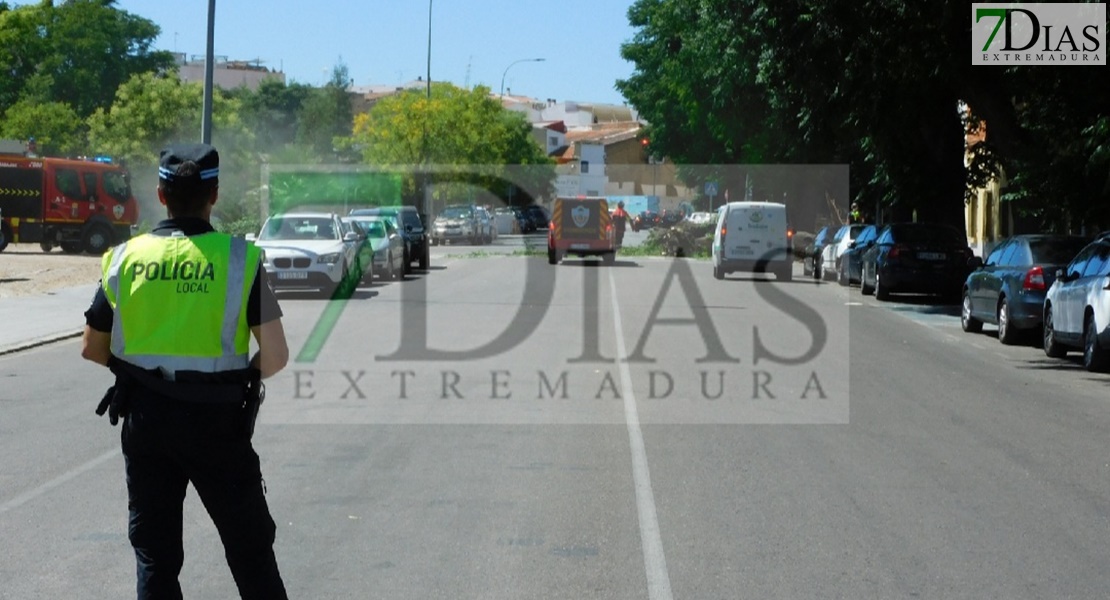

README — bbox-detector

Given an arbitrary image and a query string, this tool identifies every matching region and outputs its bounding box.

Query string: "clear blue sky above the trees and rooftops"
[21,0,633,104]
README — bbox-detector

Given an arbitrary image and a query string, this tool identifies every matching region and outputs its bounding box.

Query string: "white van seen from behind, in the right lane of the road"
[713,202,794,282]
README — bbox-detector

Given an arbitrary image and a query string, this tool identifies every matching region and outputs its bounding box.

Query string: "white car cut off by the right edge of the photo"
[1042,235,1110,372]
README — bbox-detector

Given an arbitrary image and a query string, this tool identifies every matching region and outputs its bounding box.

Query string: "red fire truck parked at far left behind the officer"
[0,154,139,254]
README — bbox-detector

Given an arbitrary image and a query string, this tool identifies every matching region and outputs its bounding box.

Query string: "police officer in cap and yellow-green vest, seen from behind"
[81,144,289,600]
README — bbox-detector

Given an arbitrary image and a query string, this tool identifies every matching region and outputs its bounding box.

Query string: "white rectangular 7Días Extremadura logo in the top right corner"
[971,3,1107,67]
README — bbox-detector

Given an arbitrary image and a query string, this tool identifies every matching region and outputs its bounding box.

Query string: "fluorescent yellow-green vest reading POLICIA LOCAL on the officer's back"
[102,233,260,379]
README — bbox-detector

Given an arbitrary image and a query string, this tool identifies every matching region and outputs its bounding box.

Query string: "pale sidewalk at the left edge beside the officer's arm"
[0,284,97,355]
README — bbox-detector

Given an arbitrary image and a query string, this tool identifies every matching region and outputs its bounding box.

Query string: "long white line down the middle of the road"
[608,270,674,600]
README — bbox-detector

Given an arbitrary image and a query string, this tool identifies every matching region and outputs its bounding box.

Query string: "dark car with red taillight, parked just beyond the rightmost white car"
[960,235,1090,344]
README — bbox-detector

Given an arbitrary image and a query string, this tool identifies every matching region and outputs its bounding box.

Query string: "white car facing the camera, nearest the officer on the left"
[255,213,363,294]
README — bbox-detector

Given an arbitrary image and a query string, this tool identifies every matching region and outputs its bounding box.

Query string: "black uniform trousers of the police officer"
[121,389,287,600]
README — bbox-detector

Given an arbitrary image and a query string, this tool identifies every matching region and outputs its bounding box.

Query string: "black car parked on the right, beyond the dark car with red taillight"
[860,223,972,302]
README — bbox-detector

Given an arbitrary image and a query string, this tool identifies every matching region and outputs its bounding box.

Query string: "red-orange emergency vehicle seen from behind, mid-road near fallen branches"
[547,196,617,265]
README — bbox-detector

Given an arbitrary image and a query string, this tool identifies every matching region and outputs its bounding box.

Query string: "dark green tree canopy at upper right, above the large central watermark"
[617,0,1110,230]
